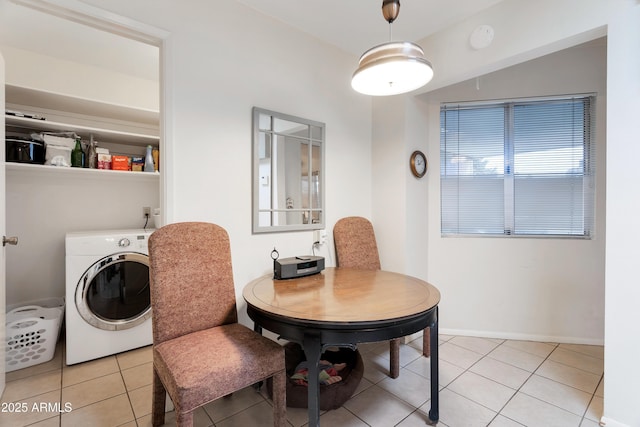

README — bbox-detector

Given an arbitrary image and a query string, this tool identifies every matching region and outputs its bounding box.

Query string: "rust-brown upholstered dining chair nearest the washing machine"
[149,222,287,426]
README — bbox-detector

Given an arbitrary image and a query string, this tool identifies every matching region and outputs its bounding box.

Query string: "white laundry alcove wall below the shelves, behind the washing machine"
[6,170,159,305]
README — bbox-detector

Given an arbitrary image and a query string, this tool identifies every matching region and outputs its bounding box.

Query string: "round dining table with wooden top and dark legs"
[243,267,440,427]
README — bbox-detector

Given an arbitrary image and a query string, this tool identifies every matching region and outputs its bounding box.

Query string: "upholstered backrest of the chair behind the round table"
[333,216,380,270]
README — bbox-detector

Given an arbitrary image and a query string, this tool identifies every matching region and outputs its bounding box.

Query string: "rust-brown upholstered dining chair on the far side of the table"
[333,216,431,378]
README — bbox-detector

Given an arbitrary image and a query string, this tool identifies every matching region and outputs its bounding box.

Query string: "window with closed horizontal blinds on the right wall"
[440,95,595,238]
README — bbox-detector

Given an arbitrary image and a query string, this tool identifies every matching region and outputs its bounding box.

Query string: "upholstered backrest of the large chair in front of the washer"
[149,222,238,344]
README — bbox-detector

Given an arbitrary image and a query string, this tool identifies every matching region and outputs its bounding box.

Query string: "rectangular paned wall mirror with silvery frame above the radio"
[253,107,325,233]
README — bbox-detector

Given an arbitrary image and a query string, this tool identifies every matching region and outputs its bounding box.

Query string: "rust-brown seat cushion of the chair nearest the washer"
[153,323,285,412]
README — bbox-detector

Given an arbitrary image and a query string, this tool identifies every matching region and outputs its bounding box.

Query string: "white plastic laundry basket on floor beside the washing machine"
[5,299,64,372]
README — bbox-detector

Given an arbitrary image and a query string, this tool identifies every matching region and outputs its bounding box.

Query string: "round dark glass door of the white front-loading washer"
[75,252,151,331]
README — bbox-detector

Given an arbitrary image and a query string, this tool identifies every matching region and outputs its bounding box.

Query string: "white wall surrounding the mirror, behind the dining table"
[77,0,372,322]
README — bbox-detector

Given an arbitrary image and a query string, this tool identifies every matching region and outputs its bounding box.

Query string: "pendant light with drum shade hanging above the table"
[351,0,433,96]
